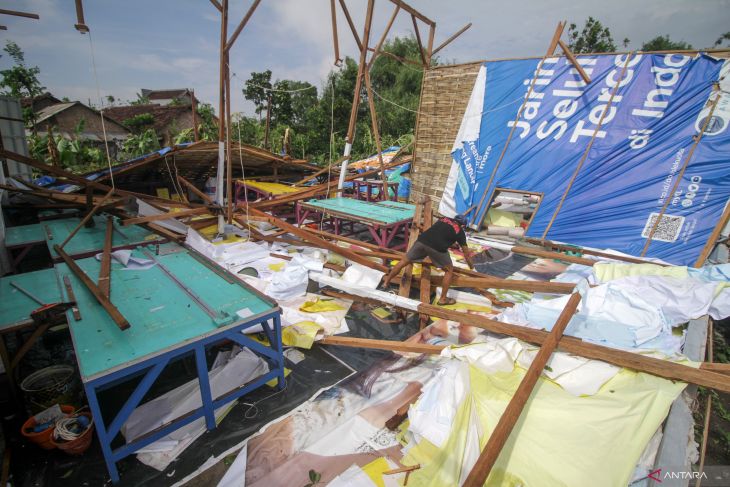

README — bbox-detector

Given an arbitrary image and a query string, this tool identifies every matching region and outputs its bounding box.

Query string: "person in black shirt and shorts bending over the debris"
[383,215,474,305]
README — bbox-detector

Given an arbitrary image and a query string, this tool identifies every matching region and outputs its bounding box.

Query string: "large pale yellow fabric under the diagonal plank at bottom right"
[402,366,686,487]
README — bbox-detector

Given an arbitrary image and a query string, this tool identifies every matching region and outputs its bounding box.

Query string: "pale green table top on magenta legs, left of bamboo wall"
[305,198,416,225]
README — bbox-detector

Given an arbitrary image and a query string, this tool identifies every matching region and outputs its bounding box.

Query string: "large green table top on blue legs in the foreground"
[56,244,275,381]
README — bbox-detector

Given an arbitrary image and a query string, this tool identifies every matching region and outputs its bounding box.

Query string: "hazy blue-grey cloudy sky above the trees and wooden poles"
[0,0,730,114]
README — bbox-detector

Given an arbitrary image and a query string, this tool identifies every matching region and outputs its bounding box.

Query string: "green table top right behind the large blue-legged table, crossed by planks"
[41,215,161,259]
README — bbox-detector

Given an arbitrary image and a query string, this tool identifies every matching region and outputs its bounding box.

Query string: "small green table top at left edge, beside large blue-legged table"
[0,268,62,332]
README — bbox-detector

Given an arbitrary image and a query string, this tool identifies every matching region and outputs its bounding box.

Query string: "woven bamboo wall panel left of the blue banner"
[411,62,482,208]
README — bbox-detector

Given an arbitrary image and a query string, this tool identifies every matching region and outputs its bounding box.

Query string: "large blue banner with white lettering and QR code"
[439,54,730,265]
